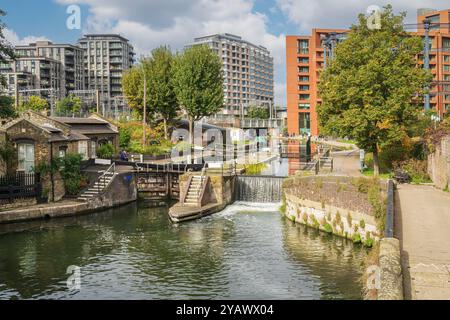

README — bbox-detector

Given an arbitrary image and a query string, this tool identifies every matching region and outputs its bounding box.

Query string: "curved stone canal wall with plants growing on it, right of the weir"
[283,176,386,246]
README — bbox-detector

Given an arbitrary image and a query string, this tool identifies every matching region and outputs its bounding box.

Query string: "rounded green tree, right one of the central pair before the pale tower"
[172,45,223,151]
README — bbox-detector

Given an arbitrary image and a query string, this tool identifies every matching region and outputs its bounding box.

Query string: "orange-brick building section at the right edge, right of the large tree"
[416,9,450,117]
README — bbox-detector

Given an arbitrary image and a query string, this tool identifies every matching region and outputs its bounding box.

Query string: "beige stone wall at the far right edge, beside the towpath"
[428,135,450,190]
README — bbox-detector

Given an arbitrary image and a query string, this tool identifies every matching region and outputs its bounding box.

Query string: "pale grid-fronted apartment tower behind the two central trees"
[192,33,274,116]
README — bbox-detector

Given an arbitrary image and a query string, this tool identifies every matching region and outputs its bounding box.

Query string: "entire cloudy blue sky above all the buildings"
[0,0,450,105]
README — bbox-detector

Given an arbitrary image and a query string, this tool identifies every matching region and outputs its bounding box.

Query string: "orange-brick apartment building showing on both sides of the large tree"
[286,9,450,135]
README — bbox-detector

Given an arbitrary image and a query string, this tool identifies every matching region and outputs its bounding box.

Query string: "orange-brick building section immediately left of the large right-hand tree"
[286,29,346,135]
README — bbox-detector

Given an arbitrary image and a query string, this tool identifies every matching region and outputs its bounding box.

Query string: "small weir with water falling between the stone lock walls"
[235,176,284,203]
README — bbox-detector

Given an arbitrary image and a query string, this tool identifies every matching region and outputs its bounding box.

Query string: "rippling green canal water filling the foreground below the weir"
[0,202,367,299]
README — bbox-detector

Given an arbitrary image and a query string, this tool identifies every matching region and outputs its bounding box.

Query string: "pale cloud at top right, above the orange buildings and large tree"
[277,0,449,34]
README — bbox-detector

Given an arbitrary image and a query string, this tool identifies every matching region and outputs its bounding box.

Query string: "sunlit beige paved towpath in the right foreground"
[395,185,450,300]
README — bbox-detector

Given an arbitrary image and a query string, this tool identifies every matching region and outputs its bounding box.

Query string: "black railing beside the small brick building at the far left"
[0,172,42,202]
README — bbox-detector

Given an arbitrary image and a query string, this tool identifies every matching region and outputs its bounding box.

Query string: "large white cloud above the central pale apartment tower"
[57,0,286,104]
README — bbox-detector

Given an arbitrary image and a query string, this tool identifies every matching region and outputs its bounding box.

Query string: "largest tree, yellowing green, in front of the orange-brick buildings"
[317,6,432,176]
